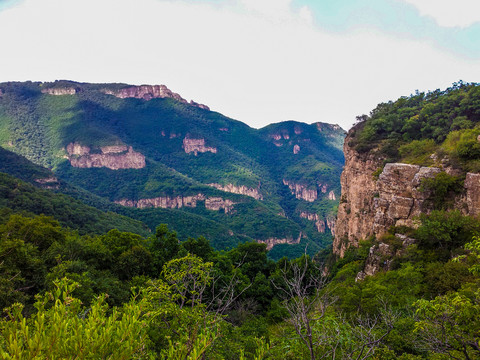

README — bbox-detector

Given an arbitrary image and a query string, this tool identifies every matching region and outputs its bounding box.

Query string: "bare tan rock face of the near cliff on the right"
[333,136,480,257]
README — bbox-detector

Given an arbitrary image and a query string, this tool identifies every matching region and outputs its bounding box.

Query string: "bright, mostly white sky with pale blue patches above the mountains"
[0,0,480,130]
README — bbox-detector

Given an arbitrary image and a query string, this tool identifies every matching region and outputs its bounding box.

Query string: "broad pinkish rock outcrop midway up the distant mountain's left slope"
[66,143,145,170]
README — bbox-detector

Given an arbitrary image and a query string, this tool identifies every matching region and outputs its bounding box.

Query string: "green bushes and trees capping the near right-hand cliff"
[350,81,480,171]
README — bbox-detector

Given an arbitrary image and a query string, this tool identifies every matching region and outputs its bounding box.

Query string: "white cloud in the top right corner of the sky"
[404,0,480,28]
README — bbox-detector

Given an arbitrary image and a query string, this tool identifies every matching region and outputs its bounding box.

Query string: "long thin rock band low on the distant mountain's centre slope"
[115,194,235,214]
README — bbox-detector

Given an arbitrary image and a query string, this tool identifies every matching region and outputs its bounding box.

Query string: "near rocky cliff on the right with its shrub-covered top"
[333,82,480,257]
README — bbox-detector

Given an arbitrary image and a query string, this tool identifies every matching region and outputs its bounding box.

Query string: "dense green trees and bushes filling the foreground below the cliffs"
[0,210,480,359]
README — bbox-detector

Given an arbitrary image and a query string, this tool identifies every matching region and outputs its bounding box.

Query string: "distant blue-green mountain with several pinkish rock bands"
[0,81,344,258]
